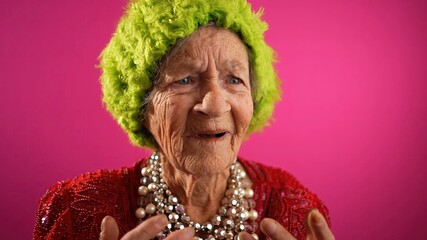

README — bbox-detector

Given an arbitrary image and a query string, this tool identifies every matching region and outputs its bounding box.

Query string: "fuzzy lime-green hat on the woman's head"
[100,0,280,148]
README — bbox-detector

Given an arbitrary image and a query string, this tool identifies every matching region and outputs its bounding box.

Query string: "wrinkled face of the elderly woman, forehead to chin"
[144,27,253,176]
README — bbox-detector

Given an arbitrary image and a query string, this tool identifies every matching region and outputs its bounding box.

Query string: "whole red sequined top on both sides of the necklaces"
[33,159,330,240]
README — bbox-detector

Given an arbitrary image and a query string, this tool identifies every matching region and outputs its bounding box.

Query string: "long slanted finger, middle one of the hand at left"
[122,215,168,240]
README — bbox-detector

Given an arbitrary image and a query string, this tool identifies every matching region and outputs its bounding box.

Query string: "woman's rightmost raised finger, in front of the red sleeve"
[307,209,335,240]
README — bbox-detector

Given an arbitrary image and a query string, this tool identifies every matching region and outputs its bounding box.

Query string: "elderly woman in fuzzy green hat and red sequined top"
[34,0,333,240]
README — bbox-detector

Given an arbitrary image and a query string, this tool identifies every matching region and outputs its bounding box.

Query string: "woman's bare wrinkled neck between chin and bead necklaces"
[162,155,230,223]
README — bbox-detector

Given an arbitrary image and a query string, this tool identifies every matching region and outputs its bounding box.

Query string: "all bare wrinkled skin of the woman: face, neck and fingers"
[100,26,333,240]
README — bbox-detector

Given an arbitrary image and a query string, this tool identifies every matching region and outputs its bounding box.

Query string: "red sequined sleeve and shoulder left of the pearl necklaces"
[33,168,139,240]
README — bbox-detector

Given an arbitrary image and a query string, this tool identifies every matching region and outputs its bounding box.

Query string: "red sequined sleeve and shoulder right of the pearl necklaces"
[241,160,331,240]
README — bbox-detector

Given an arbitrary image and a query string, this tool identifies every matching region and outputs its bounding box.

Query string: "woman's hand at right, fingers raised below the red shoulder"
[239,209,335,240]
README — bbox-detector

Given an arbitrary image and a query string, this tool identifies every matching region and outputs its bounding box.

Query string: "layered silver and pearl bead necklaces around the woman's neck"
[135,153,258,240]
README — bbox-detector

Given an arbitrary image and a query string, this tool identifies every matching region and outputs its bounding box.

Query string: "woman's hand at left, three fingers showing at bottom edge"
[99,215,194,240]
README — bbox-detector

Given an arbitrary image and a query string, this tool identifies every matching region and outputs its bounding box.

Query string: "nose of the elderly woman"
[194,84,231,117]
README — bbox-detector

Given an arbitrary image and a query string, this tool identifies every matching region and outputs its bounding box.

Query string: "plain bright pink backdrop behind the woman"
[0,0,427,239]
